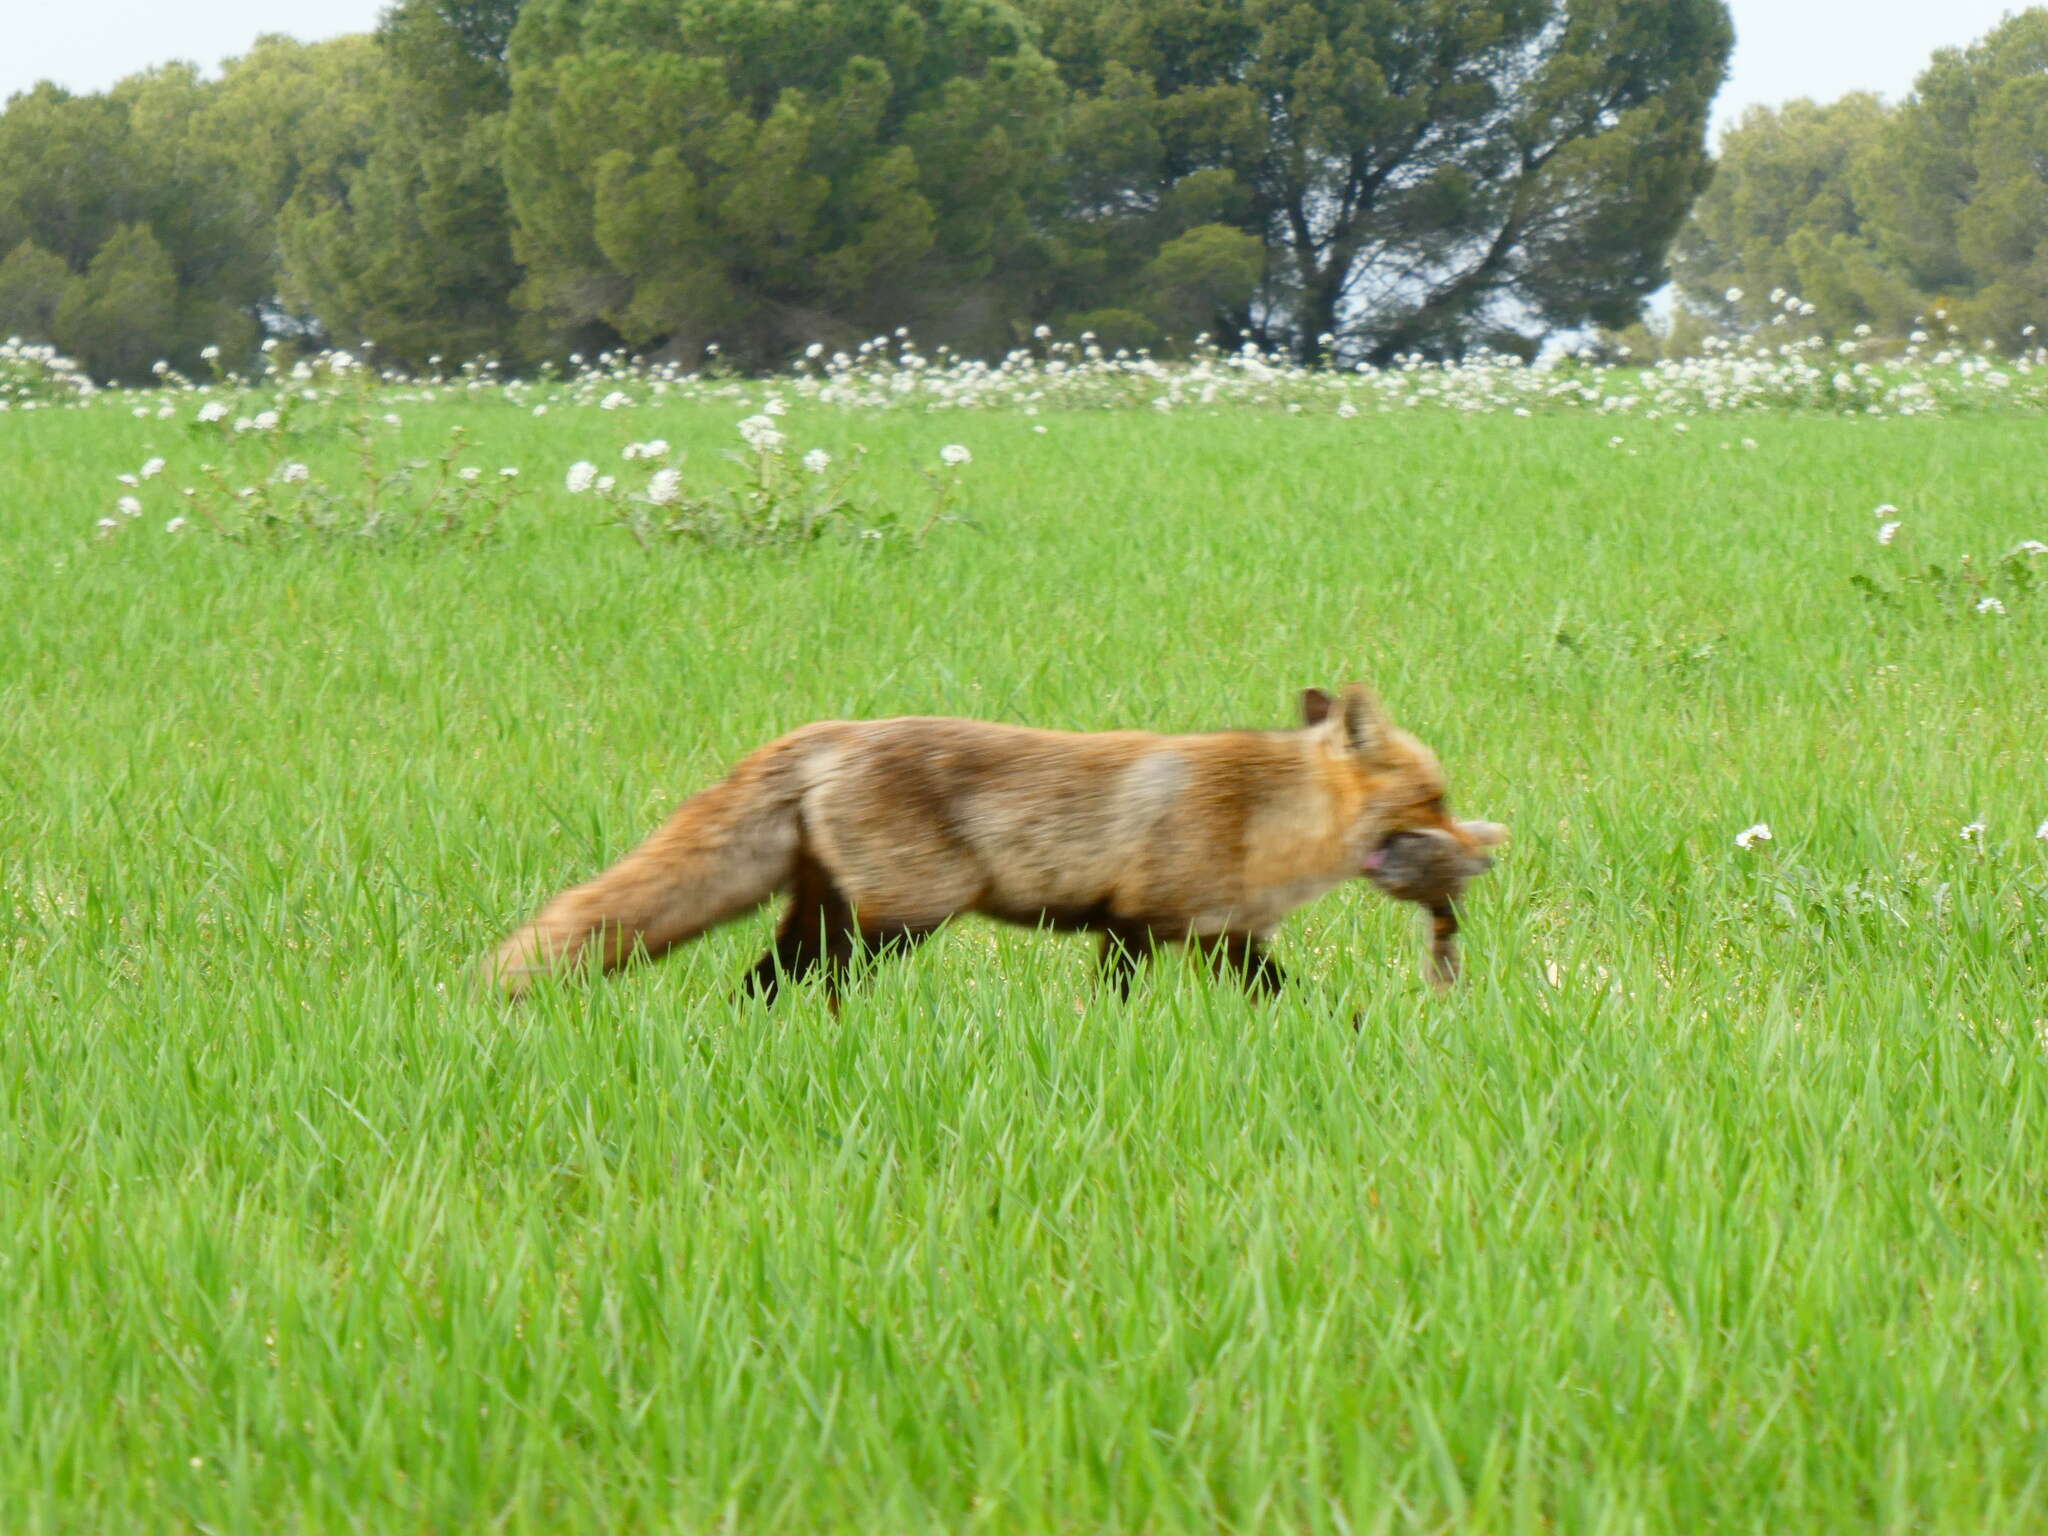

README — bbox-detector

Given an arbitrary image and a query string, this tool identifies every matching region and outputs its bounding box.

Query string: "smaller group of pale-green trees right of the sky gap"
[1673,8,2048,350]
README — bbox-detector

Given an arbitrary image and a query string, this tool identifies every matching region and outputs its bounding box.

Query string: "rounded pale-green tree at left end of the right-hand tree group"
[1673,92,1921,336]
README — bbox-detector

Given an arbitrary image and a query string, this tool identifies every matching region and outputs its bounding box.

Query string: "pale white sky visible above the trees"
[0,0,2025,123]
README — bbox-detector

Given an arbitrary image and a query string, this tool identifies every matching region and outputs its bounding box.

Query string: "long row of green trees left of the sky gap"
[0,0,1744,381]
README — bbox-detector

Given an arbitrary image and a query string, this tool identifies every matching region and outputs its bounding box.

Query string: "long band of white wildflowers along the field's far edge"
[24,295,2048,432]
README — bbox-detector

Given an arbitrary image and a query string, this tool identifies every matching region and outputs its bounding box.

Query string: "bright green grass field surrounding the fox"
[0,387,2048,1536]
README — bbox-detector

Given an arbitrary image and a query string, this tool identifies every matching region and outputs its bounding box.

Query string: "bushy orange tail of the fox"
[489,727,831,997]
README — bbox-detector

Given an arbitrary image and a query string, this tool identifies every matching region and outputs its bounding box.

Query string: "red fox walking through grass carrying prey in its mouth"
[489,684,1499,1001]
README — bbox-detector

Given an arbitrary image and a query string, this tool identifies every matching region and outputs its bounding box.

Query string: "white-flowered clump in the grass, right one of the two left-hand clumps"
[563,415,973,549]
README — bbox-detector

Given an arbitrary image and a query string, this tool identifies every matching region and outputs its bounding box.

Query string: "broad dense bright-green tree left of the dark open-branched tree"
[504,0,1061,362]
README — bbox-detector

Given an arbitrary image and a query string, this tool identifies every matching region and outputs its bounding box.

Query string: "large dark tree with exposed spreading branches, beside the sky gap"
[1024,0,1731,362]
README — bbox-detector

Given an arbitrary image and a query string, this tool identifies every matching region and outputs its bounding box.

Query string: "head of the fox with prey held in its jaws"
[1300,682,1507,899]
